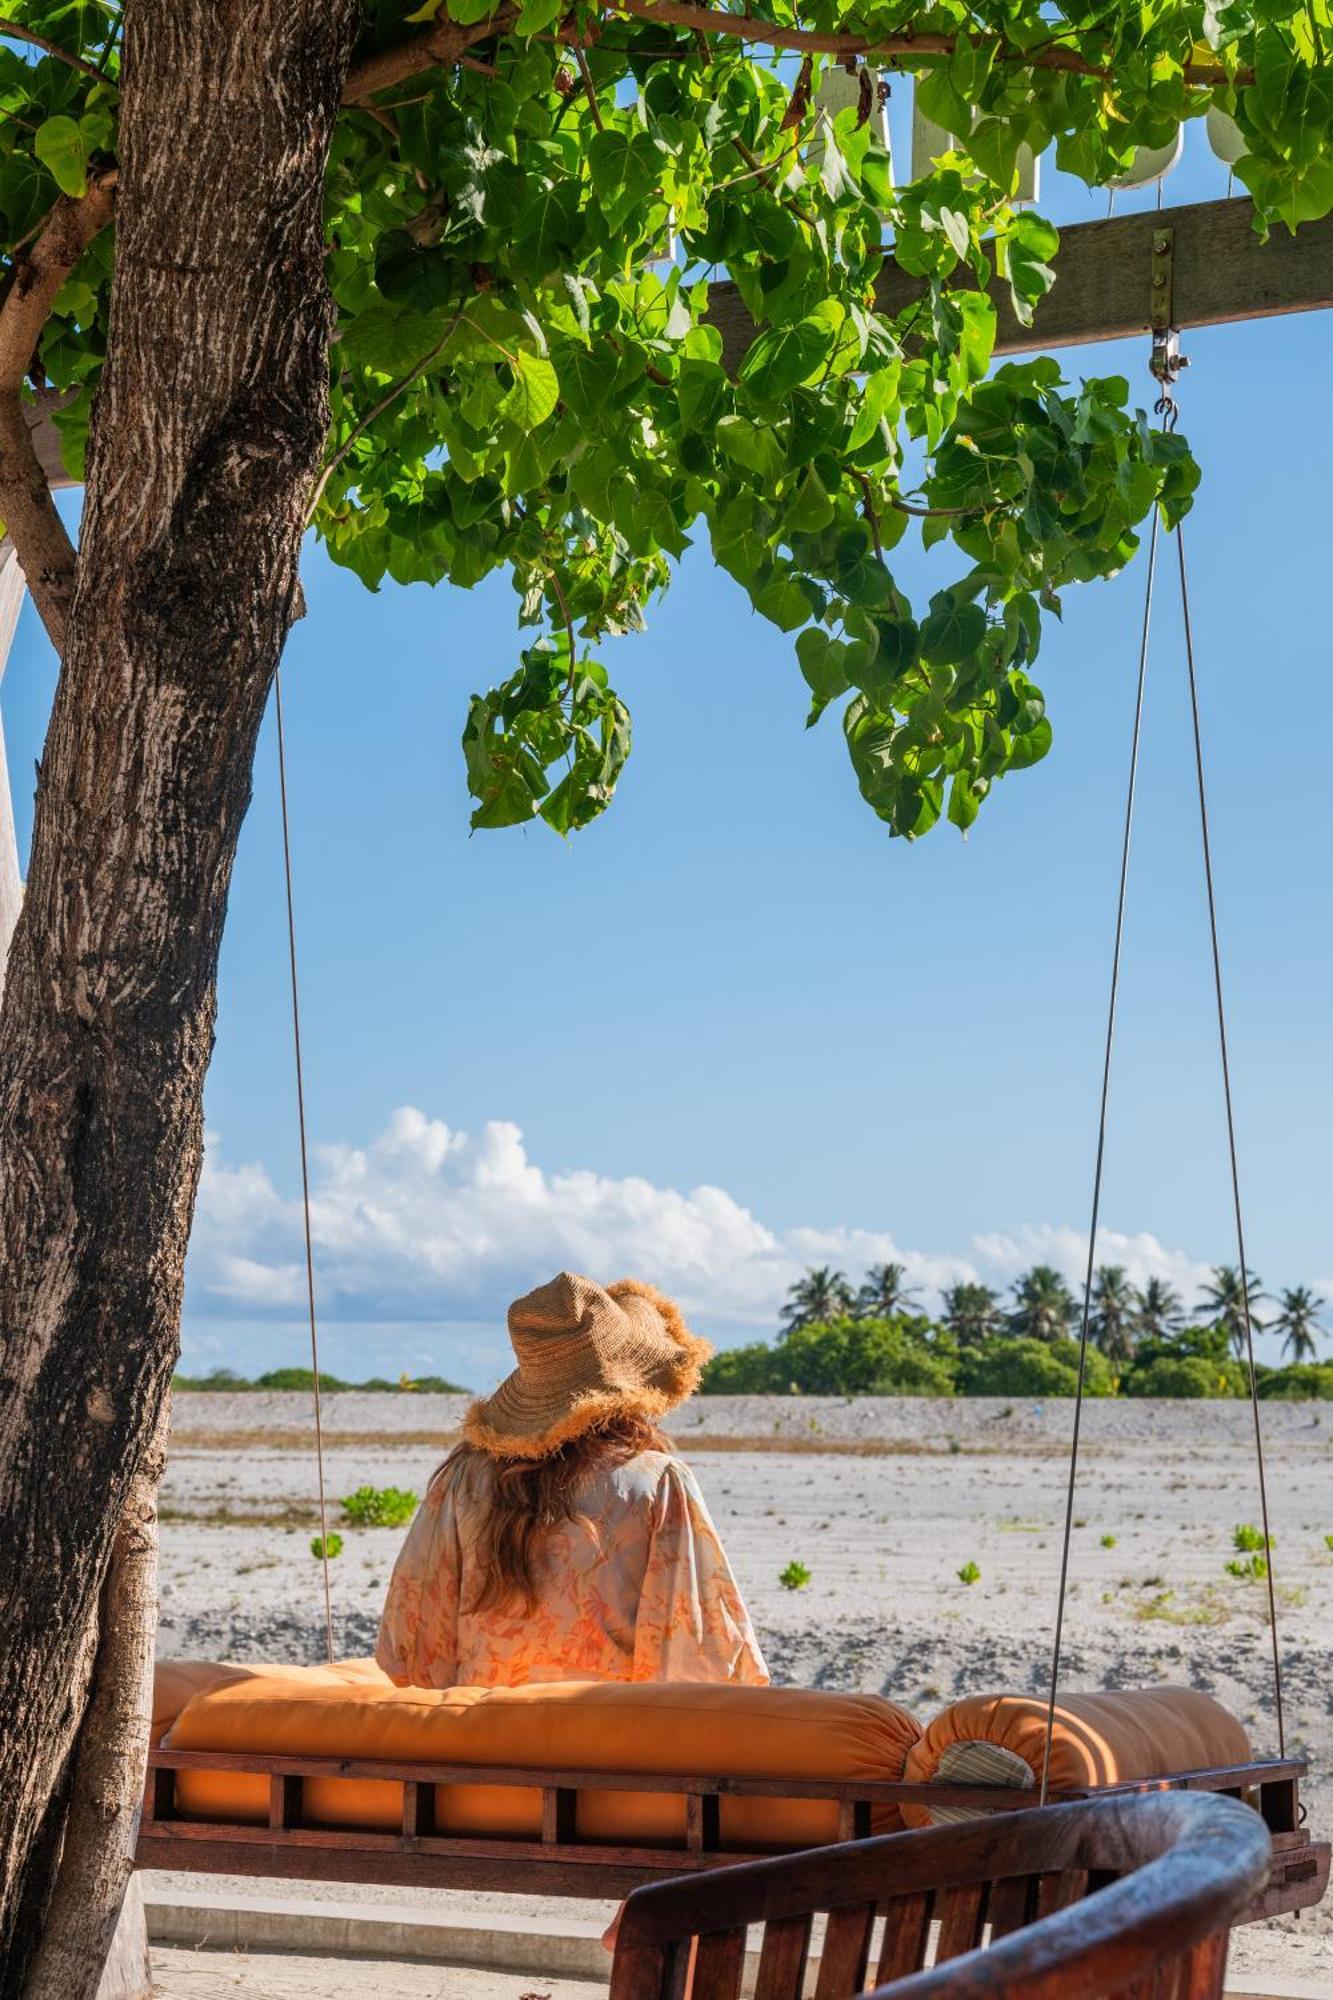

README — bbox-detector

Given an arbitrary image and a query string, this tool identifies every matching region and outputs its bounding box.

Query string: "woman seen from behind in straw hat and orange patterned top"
[376,1272,769,1688]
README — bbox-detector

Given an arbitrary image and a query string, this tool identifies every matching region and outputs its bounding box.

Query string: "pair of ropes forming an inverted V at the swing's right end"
[1039,376,1287,1806]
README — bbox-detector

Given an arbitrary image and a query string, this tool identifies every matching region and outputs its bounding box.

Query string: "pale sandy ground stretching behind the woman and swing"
[160,1392,1333,1990]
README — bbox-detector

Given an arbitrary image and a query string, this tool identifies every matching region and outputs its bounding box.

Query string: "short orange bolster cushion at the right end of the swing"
[903,1688,1253,1826]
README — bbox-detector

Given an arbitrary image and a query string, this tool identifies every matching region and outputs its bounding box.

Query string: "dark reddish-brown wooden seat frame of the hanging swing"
[134,1746,1331,1924]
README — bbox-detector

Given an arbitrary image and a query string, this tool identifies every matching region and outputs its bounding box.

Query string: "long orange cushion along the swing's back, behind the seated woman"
[168,1662,921,1850]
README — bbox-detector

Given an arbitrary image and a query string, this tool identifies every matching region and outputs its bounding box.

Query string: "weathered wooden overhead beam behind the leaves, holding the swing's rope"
[709,200,1333,370]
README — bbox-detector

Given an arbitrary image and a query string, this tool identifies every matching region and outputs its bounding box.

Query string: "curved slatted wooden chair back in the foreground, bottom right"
[610,1792,1271,2000]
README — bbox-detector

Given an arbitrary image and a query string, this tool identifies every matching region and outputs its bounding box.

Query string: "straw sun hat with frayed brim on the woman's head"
[462,1270,713,1458]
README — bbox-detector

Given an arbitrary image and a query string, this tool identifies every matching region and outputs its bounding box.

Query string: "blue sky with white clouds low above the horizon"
[4,113,1333,1384]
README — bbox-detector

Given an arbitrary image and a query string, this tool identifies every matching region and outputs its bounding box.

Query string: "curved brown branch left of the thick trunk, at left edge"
[0,168,116,654]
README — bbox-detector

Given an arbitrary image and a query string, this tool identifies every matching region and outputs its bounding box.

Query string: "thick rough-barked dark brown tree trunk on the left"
[0,0,360,2000]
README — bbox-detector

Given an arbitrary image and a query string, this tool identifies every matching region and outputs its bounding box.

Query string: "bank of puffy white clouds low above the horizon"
[188,1108,1205,1346]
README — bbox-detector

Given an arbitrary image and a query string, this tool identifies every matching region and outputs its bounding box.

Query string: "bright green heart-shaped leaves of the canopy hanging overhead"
[0,0,1333,836]
